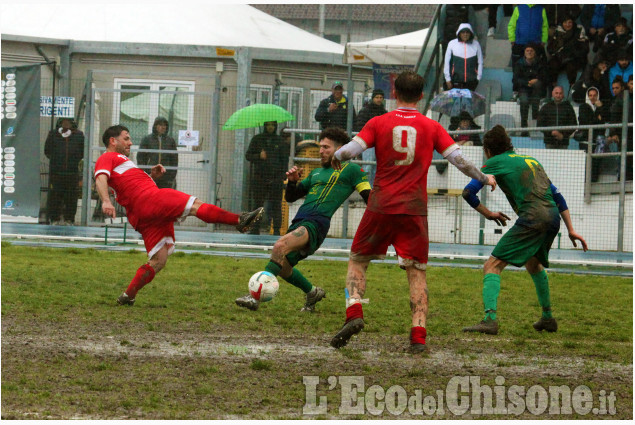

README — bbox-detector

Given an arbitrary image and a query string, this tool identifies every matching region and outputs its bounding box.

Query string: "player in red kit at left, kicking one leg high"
[95,125,263,305]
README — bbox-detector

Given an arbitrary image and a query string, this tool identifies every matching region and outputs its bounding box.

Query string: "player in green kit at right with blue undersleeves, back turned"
[463,125,587,335]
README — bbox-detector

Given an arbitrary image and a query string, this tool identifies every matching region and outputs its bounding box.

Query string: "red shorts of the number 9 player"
[351,210,429,264]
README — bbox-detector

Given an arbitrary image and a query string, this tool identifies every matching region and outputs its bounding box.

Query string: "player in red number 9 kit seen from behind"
[331,71,496,353]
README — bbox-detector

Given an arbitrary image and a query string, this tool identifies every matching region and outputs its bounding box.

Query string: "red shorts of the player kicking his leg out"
[126,189,196,258]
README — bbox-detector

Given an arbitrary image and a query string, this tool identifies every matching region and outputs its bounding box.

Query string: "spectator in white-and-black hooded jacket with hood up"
[443,23,483,90]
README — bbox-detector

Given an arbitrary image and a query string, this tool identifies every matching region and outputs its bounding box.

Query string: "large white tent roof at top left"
[0,0,343,54]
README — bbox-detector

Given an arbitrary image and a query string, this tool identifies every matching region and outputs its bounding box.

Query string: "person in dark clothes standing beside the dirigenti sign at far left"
[44,118,84,225]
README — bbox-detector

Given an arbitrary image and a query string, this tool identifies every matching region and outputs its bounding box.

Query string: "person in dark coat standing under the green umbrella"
[245,121,289,235]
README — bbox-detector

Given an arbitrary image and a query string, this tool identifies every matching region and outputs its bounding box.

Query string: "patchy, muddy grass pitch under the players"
[2,242,633,419]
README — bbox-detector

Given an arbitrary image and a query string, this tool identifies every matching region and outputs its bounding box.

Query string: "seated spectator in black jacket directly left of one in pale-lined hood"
[538,86,578,149]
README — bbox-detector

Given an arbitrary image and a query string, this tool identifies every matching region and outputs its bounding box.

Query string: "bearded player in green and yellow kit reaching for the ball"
[236,127,370,312]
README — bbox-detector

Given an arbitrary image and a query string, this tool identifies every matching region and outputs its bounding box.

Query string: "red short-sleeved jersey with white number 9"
[354,108,456,215]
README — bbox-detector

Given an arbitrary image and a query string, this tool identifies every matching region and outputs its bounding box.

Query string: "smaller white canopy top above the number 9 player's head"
[344,28,428,65]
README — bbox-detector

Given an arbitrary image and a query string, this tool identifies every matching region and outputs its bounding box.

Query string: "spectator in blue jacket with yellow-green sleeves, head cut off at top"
[507,4,549,68]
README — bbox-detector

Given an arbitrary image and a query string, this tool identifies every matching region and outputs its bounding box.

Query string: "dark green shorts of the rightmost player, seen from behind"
[492,216,560,267]
